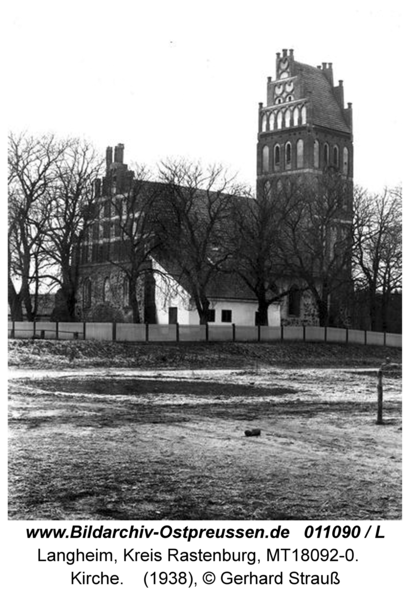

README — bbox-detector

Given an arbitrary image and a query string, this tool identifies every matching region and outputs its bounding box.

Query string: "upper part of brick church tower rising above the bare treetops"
[257,50,353,189]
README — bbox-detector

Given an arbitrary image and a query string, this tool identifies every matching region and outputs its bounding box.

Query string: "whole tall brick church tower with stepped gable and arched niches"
[257,50,353,325]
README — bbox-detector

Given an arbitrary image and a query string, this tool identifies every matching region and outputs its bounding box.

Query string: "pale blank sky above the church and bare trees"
[6,0,407,191]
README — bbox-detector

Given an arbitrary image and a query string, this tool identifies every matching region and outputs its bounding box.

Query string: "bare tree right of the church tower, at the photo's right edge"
[353,188,402,330]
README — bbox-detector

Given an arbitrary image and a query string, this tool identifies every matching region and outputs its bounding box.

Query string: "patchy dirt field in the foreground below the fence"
[9,342,401,520]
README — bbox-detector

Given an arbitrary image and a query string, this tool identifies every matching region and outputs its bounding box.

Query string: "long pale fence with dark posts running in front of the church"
[8,321,402,348]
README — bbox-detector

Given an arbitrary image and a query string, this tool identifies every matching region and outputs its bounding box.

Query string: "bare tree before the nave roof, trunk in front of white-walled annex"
[157,160,241,324]
